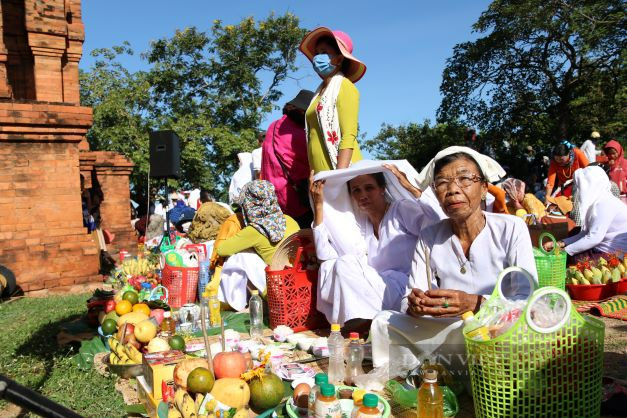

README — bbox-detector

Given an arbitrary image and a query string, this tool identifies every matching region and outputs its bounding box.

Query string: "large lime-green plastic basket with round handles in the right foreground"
[465,267,605,418]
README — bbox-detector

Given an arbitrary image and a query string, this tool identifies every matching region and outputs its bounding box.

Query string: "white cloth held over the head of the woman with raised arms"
[314,160,441,256]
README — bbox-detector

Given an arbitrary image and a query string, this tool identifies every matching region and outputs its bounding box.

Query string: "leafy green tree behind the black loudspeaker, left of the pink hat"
[81,13,305,202]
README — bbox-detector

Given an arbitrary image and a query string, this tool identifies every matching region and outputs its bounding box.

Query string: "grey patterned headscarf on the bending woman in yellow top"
[240,180,287,244]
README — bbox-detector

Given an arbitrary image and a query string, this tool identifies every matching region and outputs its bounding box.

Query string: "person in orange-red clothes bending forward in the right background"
[546,141,589,196]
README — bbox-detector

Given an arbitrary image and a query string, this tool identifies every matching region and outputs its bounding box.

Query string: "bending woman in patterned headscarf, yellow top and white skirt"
[216,180,299,311]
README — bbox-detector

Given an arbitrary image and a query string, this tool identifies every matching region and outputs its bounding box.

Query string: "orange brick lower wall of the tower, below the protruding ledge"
[0,141,99,292]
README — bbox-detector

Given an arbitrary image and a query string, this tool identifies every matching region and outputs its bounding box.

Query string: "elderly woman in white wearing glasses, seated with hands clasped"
[371,147,537,378]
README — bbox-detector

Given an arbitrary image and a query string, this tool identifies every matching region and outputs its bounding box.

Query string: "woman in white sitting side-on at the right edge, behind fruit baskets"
[544,166,627,258]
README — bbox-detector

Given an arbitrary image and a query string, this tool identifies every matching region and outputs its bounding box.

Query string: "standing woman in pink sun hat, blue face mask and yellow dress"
[300,27,366,173]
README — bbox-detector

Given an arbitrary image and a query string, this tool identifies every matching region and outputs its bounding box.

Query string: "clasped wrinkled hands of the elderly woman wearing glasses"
[407,289,482,318]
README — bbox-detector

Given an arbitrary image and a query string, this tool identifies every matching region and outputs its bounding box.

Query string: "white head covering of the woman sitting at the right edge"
[573,166,615,229]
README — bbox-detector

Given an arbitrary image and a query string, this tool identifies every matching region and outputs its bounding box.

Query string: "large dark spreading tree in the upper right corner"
[438,0,627,144]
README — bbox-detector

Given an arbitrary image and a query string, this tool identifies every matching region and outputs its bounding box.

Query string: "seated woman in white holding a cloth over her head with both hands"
[311,161,440,332]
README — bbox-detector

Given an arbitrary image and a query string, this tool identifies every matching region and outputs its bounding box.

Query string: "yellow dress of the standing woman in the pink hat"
[305,78,362,173]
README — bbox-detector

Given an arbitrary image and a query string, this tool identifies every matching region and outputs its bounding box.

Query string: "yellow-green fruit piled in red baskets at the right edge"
[566,254,627,300]
